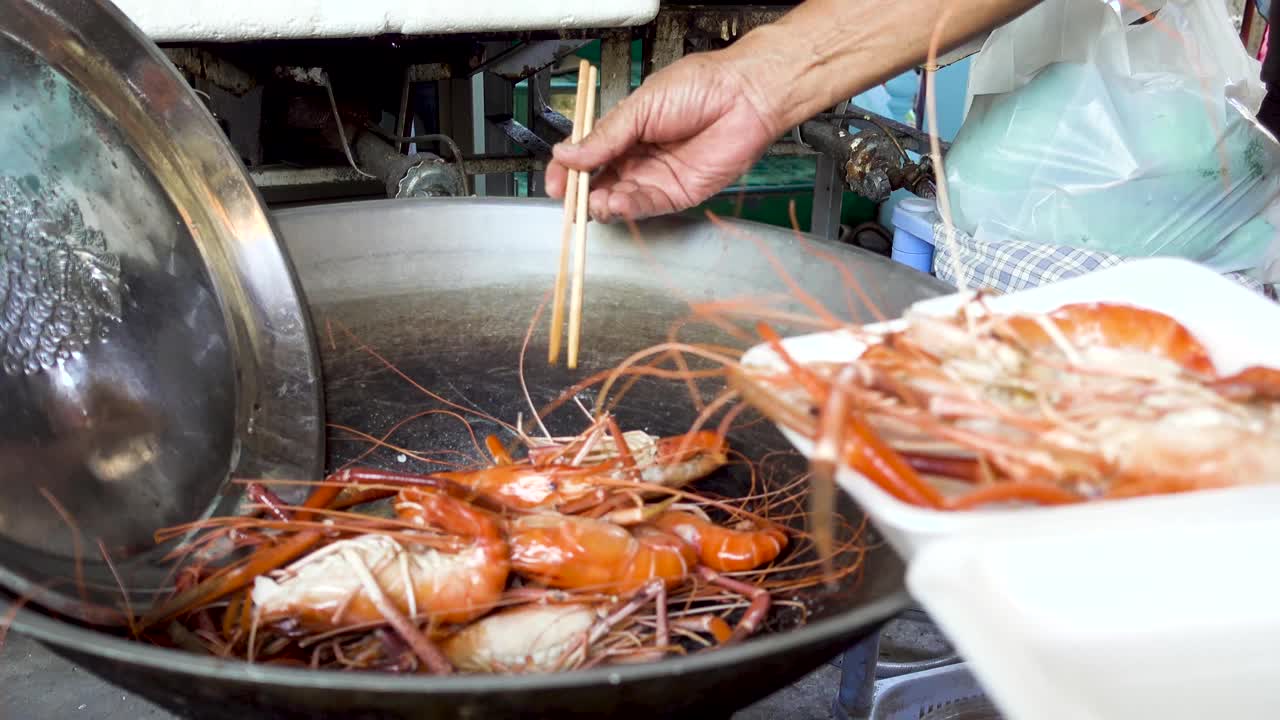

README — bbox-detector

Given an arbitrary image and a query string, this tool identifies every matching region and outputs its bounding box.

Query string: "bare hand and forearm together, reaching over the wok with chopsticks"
[547,0,1039,222]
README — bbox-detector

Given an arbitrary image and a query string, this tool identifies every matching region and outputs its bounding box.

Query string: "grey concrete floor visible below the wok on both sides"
[0,633,840,720]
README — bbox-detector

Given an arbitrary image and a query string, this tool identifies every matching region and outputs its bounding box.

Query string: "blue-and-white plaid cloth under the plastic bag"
[933,222,1276,300]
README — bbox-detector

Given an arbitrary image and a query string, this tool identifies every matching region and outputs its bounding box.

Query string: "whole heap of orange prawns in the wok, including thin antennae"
[104,301,867,674]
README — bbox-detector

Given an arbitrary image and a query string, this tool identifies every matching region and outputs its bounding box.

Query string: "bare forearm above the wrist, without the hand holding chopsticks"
[723,0,1039,131]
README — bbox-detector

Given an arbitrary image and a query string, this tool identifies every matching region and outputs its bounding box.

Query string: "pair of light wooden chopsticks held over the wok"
[547,60,599,369]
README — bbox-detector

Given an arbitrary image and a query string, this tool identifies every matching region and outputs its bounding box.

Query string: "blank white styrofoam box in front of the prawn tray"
[908,484,1280,720]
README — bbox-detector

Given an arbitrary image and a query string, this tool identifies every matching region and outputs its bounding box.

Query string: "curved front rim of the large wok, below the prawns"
[0,586,911,694]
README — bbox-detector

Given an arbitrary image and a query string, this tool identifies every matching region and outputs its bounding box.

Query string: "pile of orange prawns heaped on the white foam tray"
[733,299,1280,510]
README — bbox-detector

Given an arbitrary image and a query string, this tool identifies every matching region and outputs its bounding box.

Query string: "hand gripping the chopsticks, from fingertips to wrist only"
[547,51,785,222]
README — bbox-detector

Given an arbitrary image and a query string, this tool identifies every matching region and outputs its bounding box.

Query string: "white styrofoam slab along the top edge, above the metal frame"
[115,0,658,42]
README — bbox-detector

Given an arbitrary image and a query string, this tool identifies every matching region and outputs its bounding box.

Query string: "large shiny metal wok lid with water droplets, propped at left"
[0,0,323,623]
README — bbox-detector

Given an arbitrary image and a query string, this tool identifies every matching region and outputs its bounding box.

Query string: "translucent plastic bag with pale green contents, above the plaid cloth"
[946,0,1280,282]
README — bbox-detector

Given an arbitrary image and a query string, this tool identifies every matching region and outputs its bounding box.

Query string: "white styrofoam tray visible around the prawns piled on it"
[742,258,1280,561]
